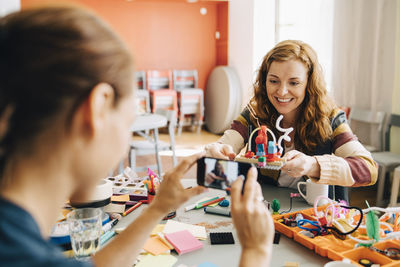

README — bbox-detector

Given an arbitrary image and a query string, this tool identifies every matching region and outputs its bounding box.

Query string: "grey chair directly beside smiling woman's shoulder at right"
[349,107,386,152]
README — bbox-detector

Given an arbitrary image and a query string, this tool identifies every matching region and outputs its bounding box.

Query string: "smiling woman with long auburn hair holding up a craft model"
[206,40,378,197]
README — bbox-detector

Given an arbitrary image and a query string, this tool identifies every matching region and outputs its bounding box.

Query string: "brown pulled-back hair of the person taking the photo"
[0,7,133,181]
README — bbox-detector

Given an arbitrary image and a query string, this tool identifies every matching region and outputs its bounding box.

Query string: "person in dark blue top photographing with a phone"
[0,7,273,267]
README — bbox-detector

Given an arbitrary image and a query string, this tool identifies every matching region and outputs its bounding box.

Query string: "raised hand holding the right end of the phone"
[231,167,274,266]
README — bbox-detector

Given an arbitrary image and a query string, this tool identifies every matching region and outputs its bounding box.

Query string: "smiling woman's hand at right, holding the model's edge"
[281,150,321,178]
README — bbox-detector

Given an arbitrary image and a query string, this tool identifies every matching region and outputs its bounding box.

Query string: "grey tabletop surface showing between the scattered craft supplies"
[118,179,329,267]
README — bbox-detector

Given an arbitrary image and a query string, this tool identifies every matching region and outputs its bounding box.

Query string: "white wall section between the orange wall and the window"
[228,0,275,110]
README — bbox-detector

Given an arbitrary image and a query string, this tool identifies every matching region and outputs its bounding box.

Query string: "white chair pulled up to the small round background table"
[129,110,177,175]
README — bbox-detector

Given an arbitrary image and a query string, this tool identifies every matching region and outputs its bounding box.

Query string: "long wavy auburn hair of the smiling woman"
[249,40,336,154]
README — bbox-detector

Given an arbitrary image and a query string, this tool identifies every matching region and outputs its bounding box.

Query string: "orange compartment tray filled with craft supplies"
[273,205,400,267]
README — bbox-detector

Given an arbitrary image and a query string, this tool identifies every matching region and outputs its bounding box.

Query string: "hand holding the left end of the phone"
[149,152,207,214]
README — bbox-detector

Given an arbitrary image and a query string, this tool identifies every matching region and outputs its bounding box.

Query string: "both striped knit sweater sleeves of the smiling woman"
[218,108,378,187]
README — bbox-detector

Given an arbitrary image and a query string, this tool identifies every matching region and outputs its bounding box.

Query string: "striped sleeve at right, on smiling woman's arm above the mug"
[315,112,378,187]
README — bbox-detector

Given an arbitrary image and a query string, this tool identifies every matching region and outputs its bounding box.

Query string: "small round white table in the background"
[123,113,168,174]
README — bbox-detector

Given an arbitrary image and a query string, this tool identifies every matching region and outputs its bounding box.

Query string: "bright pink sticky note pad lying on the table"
[165,230,203,255]
